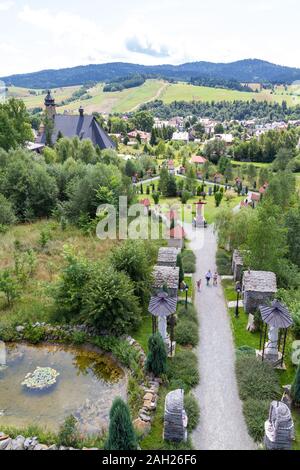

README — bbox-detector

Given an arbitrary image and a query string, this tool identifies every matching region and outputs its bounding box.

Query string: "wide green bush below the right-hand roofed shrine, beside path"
[236,355,281,400]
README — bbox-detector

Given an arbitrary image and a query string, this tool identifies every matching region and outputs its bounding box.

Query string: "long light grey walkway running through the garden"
[185,226,256,450]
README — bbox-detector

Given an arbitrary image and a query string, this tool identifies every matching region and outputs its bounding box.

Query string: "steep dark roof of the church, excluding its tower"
[40,114,115,150]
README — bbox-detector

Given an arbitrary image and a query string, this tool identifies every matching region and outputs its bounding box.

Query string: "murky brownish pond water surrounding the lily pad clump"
[0,344,127,434]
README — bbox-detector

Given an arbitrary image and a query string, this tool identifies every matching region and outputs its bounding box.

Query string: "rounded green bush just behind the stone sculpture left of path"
[167,351,199,390]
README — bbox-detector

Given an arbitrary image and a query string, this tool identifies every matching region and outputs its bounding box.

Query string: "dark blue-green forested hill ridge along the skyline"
[1,59,300,88]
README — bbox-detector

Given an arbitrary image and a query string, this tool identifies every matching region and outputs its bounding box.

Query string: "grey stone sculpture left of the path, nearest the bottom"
[164,389,188,442]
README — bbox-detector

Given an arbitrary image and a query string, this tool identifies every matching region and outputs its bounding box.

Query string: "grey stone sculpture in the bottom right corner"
[264,401,294,450]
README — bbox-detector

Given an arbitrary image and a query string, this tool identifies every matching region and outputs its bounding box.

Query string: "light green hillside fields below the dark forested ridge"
[8,79,300,113]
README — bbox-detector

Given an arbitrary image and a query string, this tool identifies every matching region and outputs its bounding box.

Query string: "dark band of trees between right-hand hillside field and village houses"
[140,100,300,122]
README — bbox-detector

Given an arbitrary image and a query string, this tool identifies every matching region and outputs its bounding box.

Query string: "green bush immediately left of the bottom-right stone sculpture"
[243,398,270,442]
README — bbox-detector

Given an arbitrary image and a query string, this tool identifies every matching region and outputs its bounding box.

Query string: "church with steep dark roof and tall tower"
[36,91,115,150]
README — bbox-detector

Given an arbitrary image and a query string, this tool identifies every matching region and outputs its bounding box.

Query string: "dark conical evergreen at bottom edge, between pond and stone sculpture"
[105,398,137,450]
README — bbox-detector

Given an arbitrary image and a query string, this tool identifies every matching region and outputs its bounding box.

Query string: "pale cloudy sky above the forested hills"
[0,0,300,76]
